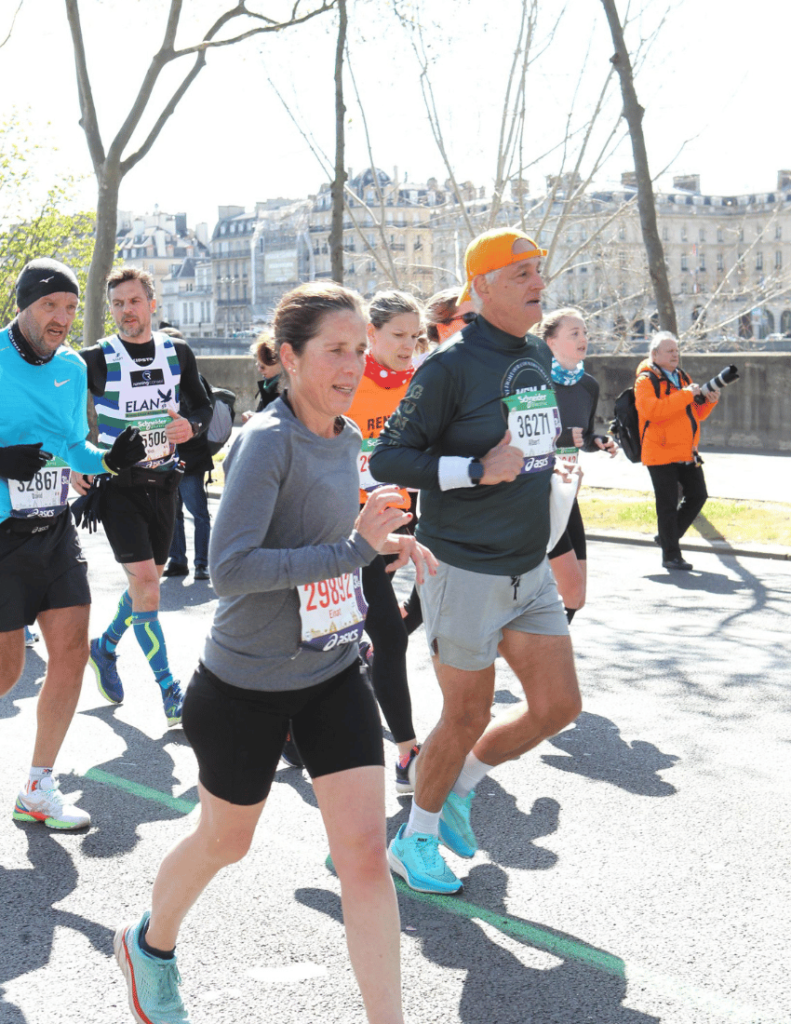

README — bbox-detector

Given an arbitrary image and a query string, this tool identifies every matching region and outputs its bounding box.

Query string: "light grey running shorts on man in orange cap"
[418,558,569,672]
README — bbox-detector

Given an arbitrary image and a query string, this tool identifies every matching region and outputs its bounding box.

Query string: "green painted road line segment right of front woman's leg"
[325,857,626,979]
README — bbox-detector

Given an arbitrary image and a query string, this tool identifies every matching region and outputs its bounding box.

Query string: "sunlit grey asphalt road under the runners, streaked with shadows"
[0,509,791,1024]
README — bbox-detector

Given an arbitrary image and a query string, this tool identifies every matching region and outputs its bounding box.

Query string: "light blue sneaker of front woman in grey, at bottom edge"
[113,910,190,1024]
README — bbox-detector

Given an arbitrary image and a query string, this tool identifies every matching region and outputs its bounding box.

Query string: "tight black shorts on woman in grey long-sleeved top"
[181,659,384,805]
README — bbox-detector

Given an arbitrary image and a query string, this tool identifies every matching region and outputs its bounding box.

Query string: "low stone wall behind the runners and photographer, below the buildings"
[198,352,791,452]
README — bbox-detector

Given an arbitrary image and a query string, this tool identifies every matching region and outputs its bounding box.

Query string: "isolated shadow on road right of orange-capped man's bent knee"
[541,712,678,797]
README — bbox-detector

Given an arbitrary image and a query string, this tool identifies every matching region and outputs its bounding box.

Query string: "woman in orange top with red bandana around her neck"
[346,292,421,794]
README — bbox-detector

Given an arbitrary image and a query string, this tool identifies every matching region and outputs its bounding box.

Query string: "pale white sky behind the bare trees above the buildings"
[0,0,791,228]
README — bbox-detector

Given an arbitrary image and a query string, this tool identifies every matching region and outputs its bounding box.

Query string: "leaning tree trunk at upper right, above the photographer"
[601,0,678,336]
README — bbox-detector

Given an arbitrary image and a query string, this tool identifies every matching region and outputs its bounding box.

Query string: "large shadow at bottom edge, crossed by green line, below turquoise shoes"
[295,864,660,1024]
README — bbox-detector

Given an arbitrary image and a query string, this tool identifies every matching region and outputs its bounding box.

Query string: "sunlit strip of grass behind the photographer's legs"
[580,487,791,548]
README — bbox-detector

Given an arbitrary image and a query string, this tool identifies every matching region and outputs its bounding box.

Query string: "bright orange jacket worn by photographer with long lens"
[634,359,714,466]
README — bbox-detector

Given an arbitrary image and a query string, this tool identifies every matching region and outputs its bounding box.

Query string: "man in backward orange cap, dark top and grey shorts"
[371,228,581,893]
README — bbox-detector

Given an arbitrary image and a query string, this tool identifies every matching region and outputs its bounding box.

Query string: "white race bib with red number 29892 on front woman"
[297,569,368,650]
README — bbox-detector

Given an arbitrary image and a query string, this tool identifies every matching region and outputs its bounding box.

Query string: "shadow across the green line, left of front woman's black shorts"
[71,707,198,857]
